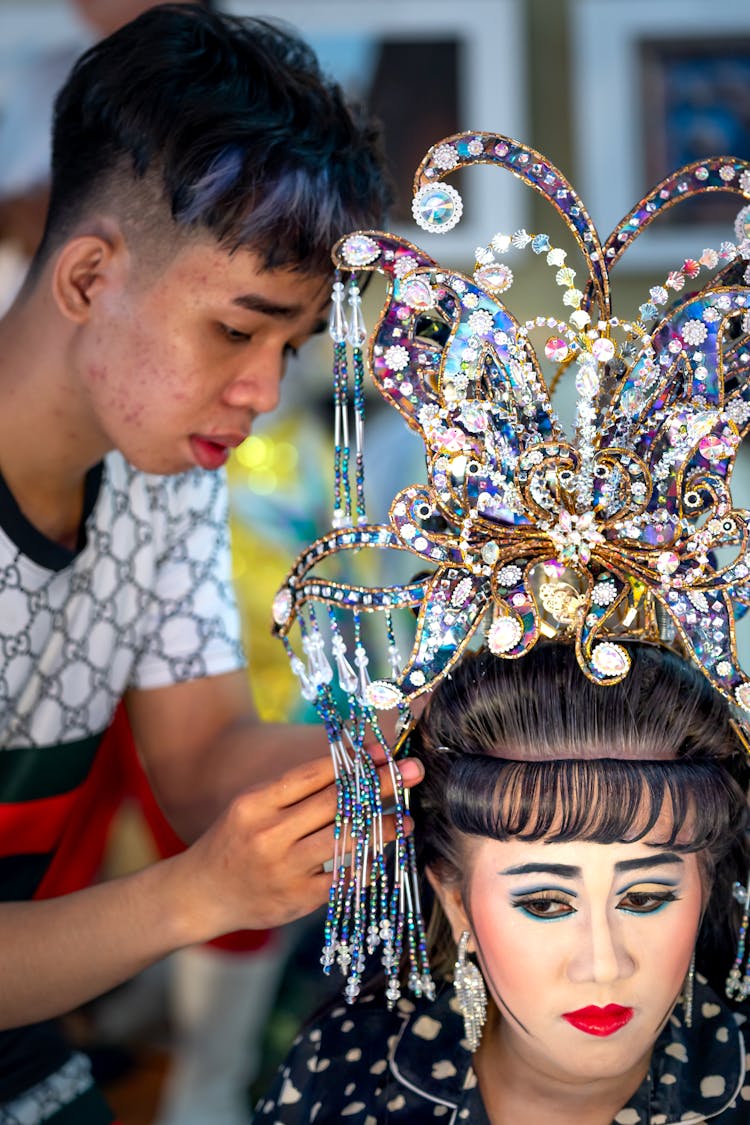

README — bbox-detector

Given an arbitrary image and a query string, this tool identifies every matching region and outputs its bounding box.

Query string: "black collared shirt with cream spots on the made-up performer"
[255,974,750,1125]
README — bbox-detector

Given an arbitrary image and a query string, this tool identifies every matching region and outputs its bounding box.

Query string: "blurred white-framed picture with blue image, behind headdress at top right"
[571,0,750,269]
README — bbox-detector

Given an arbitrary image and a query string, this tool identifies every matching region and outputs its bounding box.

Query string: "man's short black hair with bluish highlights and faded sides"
[39,5,388,273]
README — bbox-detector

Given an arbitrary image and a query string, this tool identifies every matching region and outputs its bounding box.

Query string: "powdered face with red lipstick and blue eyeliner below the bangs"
[441,837,704,1081]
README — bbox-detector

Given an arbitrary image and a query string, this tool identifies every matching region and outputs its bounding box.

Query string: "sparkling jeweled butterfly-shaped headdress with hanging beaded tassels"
[273,133,750,1000]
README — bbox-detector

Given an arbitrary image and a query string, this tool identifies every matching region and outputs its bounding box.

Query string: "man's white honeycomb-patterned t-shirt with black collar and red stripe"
[0,452,244,1107]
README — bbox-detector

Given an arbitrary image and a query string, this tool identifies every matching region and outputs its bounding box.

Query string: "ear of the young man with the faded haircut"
[52,226,127,324]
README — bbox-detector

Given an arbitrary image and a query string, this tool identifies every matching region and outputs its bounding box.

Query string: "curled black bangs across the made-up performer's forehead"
[445,755,738,852]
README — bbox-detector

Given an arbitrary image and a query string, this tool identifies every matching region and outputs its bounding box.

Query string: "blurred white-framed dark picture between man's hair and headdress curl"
[224,0,526,266]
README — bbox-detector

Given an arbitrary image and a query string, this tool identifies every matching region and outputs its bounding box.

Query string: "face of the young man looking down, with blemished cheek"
[73,241,329,474]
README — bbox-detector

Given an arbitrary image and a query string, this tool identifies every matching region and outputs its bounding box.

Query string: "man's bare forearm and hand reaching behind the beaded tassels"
[0,757,422,1027]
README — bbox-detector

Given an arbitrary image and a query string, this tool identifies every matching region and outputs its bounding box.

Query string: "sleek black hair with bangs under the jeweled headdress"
[410,642,748,983]
